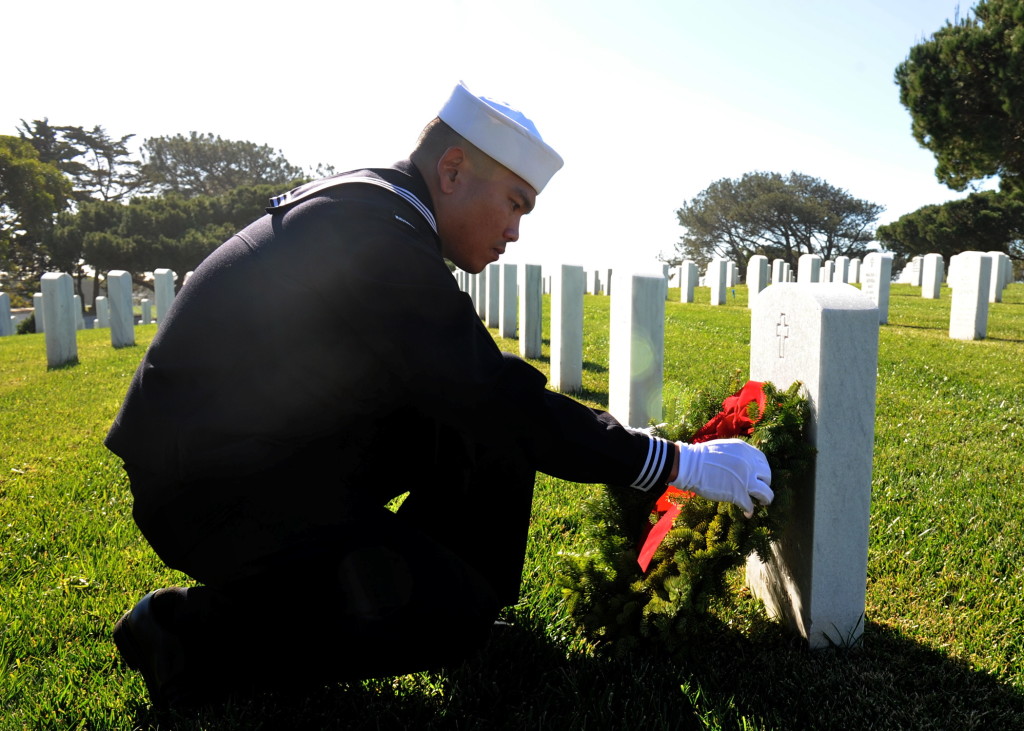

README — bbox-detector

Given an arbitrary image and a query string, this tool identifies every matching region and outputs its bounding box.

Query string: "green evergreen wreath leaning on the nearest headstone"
[561,382,814,653]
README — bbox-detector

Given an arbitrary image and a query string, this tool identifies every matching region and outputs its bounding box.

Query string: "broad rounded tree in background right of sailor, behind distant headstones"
[676,172,884,268]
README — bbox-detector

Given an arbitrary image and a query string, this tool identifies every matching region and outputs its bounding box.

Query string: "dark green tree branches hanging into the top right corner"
[895,0,1024,190]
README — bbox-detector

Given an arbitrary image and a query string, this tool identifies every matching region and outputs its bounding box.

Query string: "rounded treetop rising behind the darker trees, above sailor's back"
[142,132,303,198]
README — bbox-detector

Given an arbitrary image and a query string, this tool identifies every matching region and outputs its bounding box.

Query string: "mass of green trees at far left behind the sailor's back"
[0,119,315,304]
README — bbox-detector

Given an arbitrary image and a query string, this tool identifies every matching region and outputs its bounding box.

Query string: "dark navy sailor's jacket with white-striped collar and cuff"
[105,161,672,518]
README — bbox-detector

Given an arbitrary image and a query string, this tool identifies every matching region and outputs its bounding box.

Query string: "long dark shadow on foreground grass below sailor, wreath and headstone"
[114,610,1024,730]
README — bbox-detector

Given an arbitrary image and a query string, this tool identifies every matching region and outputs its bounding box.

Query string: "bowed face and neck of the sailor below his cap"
[438,150,537,274]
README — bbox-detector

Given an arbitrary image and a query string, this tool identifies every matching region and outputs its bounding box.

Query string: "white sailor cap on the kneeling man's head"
[437,81,562,192]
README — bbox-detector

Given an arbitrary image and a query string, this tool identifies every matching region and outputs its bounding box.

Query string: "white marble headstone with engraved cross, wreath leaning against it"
[746,284,879,648]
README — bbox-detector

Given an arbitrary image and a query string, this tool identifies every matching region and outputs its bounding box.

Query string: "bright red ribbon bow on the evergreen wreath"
[637,381,765,572]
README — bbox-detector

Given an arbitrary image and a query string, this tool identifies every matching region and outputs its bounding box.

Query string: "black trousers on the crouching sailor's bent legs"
[129,430,535,685]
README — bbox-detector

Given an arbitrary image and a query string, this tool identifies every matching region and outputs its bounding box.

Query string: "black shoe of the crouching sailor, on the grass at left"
[114,587,201,706]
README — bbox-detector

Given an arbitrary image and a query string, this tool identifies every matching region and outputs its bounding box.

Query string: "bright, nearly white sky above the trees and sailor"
[0,0,972,270]
